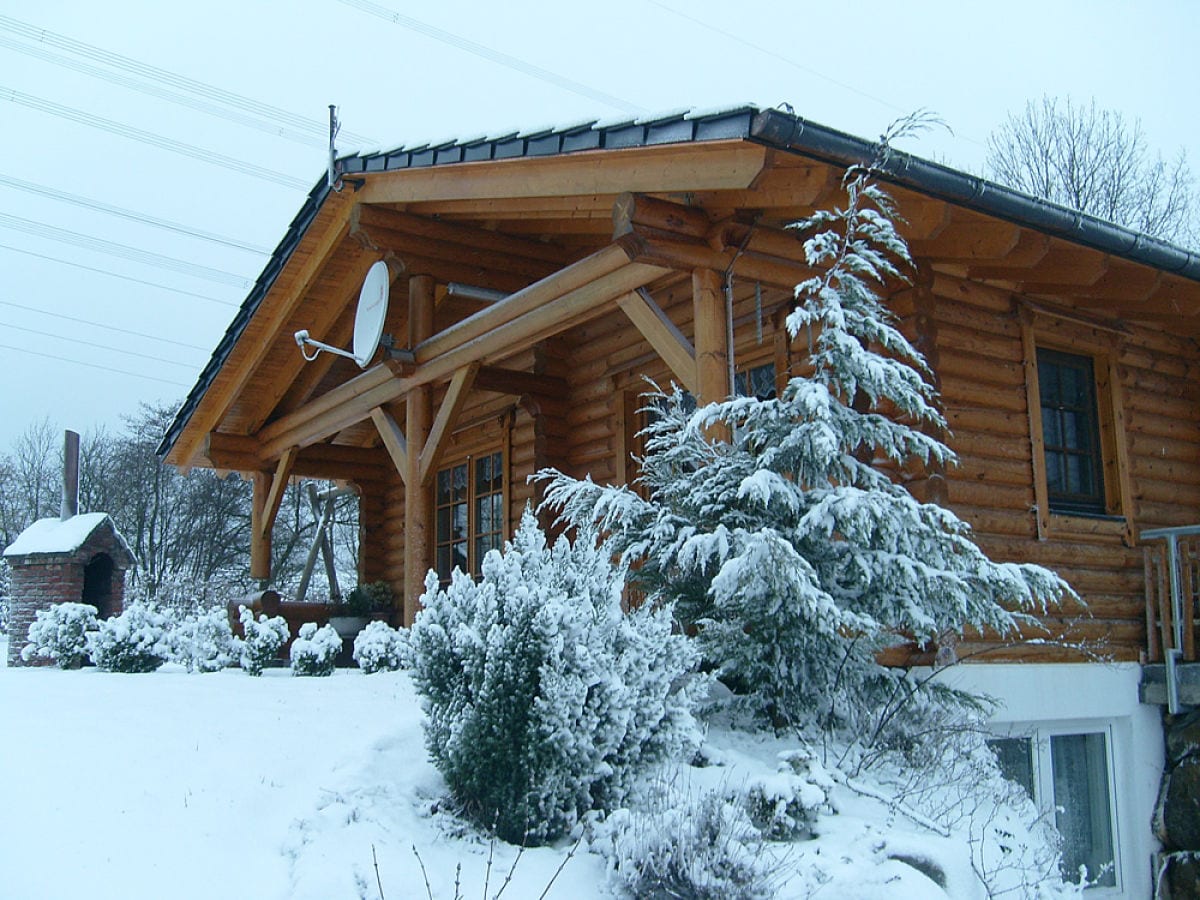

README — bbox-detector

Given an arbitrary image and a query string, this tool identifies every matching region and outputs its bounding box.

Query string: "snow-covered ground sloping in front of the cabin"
[0,644,1046,900]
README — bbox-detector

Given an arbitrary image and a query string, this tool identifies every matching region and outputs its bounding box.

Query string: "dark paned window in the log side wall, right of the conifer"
[1038,347,1105,515]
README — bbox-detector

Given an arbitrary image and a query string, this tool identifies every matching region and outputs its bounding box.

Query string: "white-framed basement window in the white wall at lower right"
[988,728,1118,888]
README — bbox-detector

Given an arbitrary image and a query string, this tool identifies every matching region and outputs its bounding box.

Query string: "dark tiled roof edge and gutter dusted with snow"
[157,106,1200,456]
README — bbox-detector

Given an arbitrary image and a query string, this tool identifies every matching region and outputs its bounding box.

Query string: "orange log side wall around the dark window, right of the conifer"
[898,276,1200,661]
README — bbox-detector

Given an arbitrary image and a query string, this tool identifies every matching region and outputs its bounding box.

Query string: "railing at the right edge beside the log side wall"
[1141,526,1200,715]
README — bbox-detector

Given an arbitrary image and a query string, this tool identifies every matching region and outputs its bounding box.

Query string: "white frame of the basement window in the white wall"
[992,720,1124,898]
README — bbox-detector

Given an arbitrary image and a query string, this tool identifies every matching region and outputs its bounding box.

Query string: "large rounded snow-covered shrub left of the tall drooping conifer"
[409,510,697,844]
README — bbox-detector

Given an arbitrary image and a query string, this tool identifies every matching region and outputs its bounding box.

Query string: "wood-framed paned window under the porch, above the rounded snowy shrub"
[436,452,505,583]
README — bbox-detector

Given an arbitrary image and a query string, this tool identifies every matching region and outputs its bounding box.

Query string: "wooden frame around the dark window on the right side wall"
[1020,304,1134,546]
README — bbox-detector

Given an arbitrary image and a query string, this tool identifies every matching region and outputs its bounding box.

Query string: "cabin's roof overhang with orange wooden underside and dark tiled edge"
[160,107,1200,476]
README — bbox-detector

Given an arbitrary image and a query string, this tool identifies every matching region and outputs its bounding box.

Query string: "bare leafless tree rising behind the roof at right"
[986,97,1200,246]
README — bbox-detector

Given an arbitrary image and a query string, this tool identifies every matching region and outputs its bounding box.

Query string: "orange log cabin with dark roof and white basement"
[160,107,1200,896]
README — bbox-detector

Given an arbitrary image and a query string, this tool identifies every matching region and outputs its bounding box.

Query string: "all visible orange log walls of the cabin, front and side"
[362,254,1200,661]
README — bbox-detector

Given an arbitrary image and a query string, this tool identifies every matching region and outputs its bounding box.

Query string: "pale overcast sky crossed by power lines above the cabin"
[0,0,1200,452]
